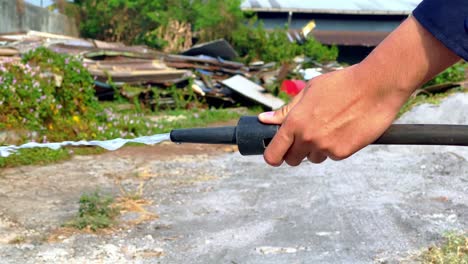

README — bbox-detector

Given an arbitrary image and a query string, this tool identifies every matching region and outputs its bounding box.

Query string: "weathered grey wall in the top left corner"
[0,0,78,36]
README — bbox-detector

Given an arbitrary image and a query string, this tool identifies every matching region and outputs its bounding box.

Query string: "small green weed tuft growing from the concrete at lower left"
[64,191,119,231]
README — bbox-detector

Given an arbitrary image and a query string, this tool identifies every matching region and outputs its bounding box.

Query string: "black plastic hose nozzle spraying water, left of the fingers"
[170,116,279,155]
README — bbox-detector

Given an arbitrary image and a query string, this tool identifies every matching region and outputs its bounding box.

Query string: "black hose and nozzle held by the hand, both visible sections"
[171,116,468,155]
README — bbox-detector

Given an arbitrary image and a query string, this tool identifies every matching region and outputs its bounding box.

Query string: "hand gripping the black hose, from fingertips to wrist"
[259,65,411,166]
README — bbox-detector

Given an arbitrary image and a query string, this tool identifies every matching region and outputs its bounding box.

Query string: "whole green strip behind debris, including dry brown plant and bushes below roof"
[57,0,338,62]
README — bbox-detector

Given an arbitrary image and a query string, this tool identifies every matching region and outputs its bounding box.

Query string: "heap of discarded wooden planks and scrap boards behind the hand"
[0,31,348,109]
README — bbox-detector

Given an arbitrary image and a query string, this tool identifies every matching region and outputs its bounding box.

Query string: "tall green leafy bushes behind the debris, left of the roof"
[70,0,243,48]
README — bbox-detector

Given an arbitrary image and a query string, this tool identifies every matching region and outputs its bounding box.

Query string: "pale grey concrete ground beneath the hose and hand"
[0,94,468,263]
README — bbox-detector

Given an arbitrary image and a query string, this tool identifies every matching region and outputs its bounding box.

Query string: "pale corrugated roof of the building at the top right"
[242,0,422,14]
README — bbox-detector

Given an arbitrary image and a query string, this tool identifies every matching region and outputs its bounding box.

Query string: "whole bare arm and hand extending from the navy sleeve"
[259,17,460,166]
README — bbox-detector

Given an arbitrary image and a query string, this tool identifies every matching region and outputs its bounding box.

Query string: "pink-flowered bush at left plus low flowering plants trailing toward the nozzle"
[0,48,177,141]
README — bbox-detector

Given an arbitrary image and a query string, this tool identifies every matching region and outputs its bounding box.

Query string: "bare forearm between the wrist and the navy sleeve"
[356,17,460,102]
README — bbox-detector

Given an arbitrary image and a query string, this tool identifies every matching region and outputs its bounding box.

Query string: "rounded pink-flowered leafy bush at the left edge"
[0,48,100,139]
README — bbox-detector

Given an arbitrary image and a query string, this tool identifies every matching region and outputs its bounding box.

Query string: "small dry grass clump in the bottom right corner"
[422,233,468,264]
